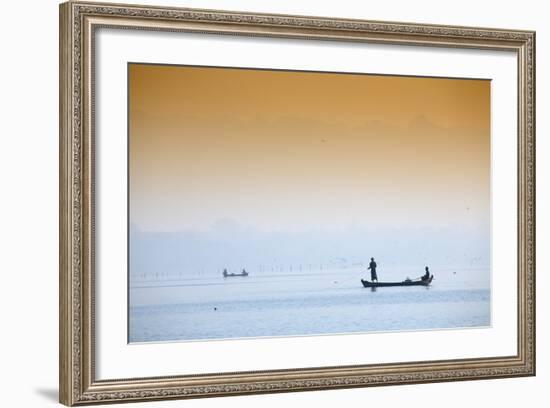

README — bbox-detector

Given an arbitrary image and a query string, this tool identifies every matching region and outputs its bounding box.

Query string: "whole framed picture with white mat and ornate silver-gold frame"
[60,2,535,405]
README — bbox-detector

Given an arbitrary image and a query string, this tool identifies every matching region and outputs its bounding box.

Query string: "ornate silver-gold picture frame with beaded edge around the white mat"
[59,2,535,406]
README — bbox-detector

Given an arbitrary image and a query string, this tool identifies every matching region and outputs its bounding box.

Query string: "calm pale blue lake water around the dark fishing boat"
[129,268,491,342]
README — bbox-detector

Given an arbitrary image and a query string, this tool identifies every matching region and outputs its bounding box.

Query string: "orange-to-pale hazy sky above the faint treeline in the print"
[129,64,490,231]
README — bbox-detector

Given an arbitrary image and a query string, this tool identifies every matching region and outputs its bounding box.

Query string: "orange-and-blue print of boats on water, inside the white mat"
[128,63,491,343]
